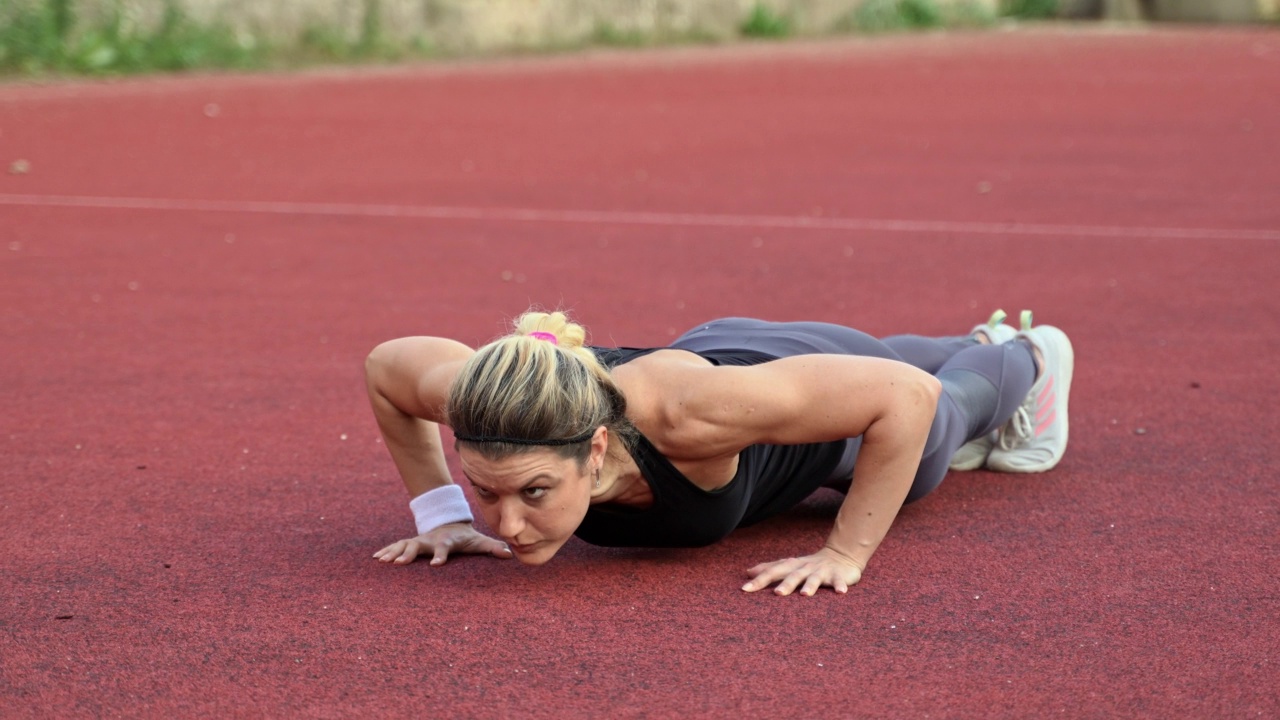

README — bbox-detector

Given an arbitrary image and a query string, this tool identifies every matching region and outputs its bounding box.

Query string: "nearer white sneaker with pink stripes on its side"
[987,325,1075,473]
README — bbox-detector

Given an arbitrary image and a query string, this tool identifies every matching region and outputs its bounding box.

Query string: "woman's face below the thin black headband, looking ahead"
[458,448,598,565]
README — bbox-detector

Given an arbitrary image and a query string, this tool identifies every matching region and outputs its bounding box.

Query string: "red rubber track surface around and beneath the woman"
[0,28,1280,719]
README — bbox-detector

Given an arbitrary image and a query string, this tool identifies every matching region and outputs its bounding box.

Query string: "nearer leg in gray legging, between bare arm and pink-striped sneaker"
[906,342,1036,502]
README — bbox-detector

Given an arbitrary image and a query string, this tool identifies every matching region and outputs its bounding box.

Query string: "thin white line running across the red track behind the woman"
[0,193,1280,241]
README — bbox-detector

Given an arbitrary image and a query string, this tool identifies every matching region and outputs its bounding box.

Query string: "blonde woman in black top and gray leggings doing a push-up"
[366,311,1073,596]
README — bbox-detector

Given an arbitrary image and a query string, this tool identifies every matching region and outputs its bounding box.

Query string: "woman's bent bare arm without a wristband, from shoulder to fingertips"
[660,355,941,594]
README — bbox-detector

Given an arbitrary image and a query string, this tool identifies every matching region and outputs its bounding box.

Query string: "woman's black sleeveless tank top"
[576,347,846,547]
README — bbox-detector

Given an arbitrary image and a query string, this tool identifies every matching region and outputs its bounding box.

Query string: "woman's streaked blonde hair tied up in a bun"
[445,310,635,462]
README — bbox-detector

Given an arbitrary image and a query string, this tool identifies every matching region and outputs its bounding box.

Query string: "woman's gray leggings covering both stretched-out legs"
[671,318,1036,502]
